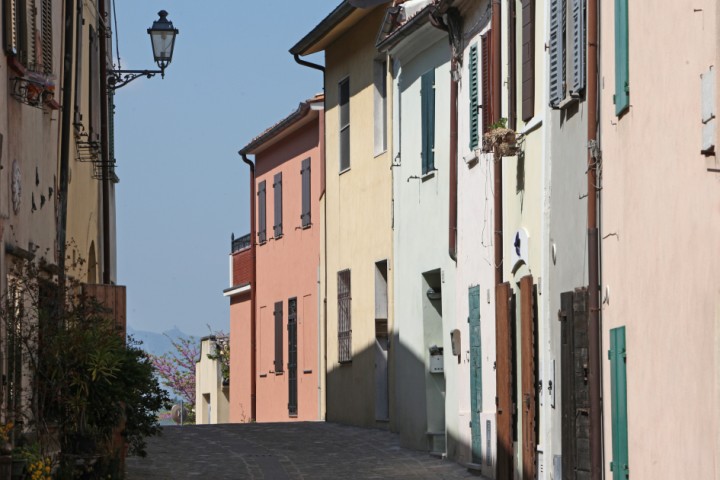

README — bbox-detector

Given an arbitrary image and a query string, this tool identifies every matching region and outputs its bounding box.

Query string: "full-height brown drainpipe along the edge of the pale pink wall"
[587,0,603,480]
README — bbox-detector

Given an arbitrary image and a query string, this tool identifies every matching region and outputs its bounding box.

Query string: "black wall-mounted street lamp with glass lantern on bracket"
[108,10,179,90]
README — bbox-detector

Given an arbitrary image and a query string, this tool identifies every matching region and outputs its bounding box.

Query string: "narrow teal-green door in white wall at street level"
[468,286,482,464]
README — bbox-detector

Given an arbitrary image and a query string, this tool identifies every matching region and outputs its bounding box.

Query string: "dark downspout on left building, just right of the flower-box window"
[57,0,75,285]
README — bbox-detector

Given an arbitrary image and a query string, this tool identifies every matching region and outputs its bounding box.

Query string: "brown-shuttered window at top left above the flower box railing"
[5,0,53,75]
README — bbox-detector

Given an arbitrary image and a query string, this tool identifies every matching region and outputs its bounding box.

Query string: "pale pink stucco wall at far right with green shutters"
[600,0,720,478]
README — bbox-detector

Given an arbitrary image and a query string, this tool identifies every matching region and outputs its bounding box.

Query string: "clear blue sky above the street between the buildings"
[110,0,328,336]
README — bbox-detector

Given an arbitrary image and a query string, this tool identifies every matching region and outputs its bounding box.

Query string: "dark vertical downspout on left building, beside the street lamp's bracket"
[98,0,112,285]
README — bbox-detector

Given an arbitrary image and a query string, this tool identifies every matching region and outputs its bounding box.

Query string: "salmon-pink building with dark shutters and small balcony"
[225,96,324,422]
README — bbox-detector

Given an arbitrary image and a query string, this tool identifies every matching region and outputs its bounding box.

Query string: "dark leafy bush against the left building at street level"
[0,260,168,466]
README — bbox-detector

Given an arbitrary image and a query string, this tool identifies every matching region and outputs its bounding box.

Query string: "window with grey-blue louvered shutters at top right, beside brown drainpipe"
[548,0,585,108]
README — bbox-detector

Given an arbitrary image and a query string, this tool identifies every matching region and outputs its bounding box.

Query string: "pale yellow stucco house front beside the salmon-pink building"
[325,8,394,428]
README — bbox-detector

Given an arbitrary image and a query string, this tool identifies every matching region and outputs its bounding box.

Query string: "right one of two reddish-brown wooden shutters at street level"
[520,275,538,479]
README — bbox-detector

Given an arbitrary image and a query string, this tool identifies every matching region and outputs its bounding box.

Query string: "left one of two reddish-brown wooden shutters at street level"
[495,283,515,480]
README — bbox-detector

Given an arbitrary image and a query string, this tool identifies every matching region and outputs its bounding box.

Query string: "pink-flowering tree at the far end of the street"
[152,337,200,409]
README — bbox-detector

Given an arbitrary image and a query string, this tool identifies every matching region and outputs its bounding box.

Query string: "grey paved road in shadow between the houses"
[127,423,486,480]
